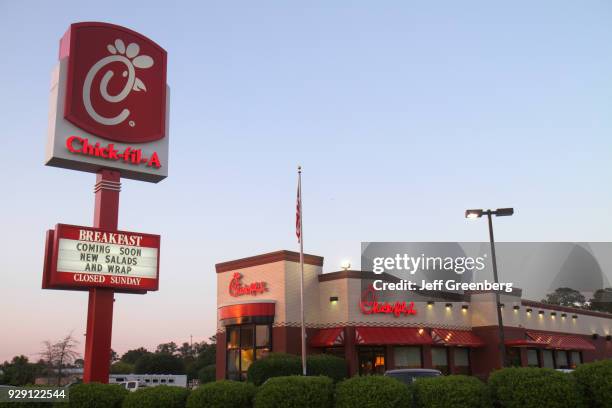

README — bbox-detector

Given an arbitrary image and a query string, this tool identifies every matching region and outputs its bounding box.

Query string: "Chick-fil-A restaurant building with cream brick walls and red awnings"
[216,251,612,379]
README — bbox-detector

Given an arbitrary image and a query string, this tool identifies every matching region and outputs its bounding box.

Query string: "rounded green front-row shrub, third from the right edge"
[413,375,492,408]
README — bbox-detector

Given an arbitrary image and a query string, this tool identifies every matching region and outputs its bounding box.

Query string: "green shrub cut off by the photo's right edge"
[572,360,612,408]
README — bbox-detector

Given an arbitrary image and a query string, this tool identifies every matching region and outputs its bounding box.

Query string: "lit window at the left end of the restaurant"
[226,324,271,380]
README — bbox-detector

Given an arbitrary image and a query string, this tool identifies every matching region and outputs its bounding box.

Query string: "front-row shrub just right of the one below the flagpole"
[336,375,412,408]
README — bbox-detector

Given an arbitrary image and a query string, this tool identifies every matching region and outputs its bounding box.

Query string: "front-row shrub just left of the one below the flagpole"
[187,380,256,408]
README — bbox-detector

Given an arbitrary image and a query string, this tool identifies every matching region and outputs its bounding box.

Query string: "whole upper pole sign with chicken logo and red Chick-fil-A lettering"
[46,22,170,183]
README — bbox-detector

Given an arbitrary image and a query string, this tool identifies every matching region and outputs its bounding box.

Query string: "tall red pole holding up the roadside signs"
[83,169,121,384]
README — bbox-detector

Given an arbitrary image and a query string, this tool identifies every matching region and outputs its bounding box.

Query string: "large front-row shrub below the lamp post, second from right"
[489,367,582,408]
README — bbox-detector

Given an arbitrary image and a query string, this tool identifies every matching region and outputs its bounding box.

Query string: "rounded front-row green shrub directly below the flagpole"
[253,375,334,408]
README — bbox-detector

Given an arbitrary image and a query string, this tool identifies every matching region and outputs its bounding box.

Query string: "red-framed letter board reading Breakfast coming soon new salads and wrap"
[43,224,160,293]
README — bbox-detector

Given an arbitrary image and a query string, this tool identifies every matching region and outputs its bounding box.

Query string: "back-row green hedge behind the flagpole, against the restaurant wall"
[247,353,348,385]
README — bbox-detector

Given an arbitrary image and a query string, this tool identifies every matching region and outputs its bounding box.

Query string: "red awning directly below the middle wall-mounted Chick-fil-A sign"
[355,327,432,345]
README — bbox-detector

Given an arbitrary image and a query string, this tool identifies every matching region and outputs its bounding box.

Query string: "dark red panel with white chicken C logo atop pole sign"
[60,23,166,143]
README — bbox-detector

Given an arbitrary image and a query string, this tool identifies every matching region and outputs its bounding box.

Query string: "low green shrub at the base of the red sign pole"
[65,383,129,408]
